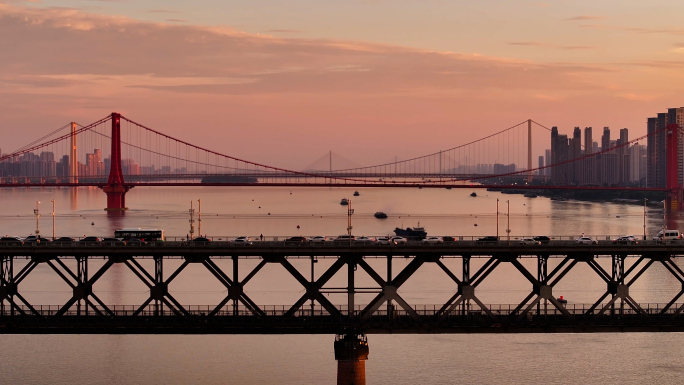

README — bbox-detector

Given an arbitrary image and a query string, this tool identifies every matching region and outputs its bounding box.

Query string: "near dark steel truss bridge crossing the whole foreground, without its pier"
[0,241,684,332]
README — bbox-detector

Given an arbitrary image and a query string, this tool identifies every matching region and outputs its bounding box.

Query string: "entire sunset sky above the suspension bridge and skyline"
[0,0,684,169]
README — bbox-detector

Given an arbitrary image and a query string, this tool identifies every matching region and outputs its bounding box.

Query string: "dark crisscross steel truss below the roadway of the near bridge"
[0,253,684,332]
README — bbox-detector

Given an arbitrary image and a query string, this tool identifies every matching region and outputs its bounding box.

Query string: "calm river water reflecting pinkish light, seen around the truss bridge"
[0,187,684,385]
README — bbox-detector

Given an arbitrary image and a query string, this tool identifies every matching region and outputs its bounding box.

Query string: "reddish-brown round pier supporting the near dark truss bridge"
[335,331,368,385]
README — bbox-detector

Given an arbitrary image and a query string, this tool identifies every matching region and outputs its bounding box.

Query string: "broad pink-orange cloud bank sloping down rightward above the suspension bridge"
[0,5,681,168]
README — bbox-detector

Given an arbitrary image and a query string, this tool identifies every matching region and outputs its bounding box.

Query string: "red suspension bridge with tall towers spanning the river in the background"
[0,113,683,210]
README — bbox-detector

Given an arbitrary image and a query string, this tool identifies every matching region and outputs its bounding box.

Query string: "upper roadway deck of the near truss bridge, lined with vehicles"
[0,240,684,259]
